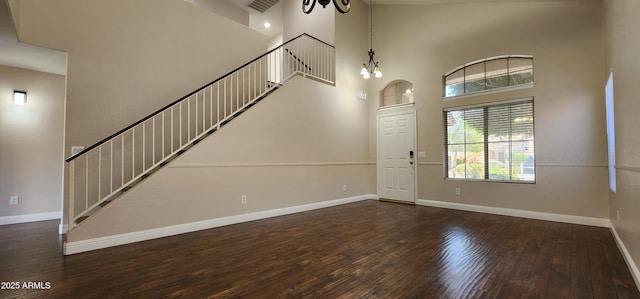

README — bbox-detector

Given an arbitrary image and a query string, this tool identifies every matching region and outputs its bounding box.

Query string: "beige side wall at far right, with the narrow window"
[600,0,640,283]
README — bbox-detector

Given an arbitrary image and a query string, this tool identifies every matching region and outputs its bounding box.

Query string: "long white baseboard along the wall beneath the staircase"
[63,194,378,255]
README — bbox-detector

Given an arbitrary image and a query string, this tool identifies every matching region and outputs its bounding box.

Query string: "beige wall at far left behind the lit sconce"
[0,66,65,217]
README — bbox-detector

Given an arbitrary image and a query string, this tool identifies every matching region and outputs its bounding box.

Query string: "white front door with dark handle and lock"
[378,111,417,203]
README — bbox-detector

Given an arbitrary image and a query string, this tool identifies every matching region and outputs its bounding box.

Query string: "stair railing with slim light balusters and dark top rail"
[66,34,335,230]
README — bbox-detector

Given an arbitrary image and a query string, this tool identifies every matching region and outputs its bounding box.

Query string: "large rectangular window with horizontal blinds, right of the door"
[444,98,535,182]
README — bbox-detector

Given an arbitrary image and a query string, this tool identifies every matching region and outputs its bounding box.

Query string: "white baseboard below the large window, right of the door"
[416,199,611,227]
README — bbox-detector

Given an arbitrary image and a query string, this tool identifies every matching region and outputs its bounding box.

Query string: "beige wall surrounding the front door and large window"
[369,1,609,218]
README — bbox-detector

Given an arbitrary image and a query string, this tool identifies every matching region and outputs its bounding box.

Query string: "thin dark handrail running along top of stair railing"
[65,33,335,162]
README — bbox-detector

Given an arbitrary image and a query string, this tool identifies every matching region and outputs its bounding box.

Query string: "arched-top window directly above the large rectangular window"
[442,55,534,98]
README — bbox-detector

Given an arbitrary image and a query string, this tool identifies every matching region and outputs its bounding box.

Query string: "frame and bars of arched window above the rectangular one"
[442,55,535,101]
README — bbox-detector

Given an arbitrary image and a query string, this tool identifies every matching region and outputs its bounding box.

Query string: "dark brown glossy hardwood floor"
[0,201,640,298]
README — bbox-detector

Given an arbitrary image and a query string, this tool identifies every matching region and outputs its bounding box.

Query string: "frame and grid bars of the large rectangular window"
[442,97,537,184]
